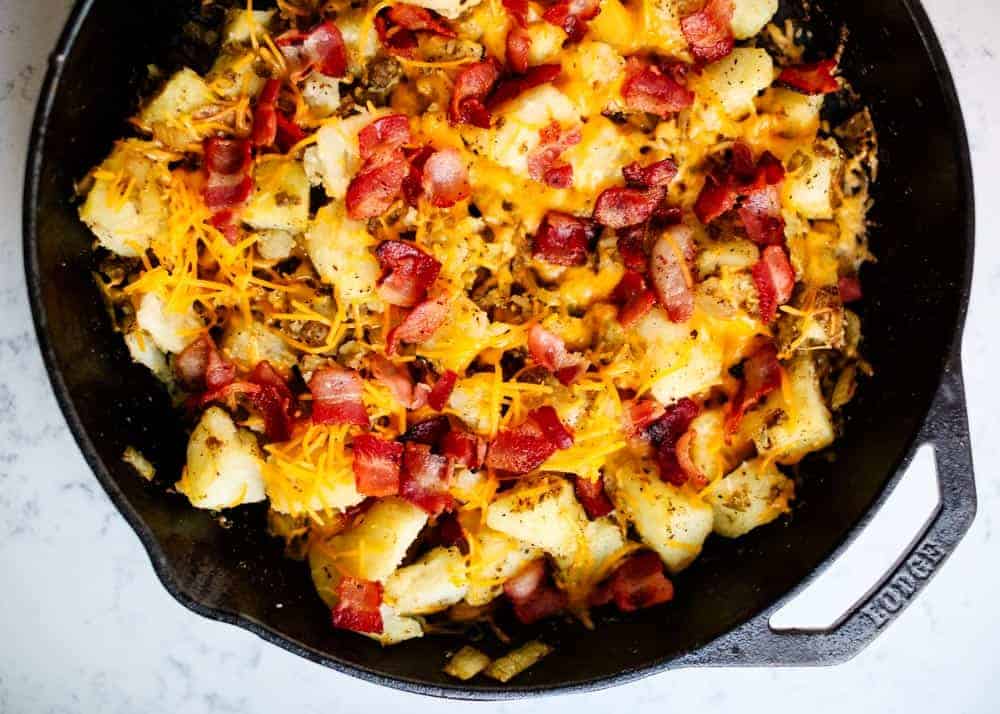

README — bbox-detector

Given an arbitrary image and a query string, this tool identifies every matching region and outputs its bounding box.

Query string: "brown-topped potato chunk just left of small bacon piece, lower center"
[486,476,587,562]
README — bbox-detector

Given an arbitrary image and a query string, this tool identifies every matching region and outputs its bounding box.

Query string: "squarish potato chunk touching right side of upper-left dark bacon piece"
[241,159,309,233]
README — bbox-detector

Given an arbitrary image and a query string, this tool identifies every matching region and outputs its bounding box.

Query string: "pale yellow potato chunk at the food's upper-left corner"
[138,67,216,151]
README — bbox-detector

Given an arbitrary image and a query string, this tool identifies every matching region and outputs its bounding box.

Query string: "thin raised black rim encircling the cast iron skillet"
[22,0,975,701]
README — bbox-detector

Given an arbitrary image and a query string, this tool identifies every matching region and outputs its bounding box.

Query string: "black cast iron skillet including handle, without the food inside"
[24,0,976,699]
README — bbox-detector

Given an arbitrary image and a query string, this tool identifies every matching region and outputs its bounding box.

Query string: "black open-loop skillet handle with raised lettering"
[674,350,976,667]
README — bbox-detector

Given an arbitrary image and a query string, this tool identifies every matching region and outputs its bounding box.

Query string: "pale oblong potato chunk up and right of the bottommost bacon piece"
[384,548,469,615]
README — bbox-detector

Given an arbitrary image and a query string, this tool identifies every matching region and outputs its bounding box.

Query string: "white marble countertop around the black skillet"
[0,0,1000,714]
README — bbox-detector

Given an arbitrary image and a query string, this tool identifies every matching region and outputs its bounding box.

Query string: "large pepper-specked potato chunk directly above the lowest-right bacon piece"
[605,461,714,573]
